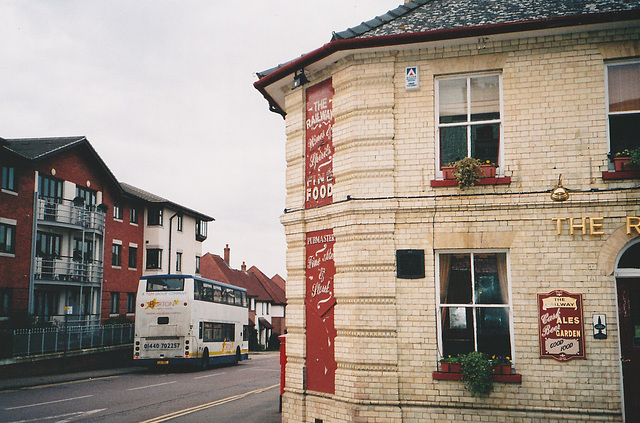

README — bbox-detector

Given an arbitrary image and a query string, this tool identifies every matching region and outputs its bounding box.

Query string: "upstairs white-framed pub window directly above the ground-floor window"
[436,74,503,176]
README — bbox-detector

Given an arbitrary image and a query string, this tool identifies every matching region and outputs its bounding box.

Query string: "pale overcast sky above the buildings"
[0,0,402,277]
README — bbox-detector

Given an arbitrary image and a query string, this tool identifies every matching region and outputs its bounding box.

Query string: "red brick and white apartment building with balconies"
[0,137,213,325]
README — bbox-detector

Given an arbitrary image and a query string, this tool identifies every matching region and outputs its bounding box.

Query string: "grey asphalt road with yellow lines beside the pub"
[0,354,280,423]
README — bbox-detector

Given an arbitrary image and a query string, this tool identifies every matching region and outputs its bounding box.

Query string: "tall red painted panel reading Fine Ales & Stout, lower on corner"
[305,229,337,394]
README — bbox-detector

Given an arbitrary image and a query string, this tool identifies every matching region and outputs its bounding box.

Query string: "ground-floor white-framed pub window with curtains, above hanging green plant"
[437,252,513,357]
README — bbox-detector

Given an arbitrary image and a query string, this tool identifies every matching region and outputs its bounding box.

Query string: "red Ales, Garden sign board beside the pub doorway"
[538,290,585,361]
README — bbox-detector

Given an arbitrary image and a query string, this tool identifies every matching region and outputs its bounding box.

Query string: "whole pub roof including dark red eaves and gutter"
[254,0,640,116]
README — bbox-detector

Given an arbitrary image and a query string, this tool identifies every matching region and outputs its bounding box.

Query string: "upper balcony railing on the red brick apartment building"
[37,198,106,233]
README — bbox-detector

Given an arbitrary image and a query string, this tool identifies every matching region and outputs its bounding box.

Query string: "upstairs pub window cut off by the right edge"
[606,62,640,160]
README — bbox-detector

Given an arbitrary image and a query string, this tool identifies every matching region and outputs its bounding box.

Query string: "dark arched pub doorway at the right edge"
[616,239,640,422]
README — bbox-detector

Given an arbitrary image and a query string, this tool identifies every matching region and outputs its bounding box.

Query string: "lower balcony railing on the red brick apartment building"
[34,257,103,284]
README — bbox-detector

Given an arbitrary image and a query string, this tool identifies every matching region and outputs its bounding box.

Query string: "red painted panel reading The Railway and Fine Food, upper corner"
[304,78,334,209]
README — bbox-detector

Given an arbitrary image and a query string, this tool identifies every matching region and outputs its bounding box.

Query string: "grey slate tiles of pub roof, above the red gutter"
[332,0,640,40]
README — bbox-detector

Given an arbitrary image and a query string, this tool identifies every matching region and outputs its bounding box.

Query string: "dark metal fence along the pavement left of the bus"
[13,323,134,357]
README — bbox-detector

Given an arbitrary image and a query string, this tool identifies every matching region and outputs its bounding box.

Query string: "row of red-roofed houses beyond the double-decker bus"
[200,245,286,348]
